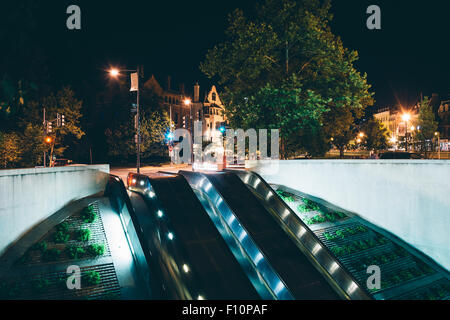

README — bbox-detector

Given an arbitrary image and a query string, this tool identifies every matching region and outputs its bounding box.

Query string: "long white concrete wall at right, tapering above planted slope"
[246,160,450,270]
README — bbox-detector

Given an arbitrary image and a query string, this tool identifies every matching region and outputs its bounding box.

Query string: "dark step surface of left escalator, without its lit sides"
[142,176,260,300]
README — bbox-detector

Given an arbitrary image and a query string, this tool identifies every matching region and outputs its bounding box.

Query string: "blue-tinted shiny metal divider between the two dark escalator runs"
[179,171,294,300]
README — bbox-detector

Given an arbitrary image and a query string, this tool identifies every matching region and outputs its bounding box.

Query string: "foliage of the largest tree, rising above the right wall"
[200,0,373,155]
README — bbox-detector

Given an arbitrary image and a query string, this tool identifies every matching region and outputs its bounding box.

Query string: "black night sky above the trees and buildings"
[3,0,450,107]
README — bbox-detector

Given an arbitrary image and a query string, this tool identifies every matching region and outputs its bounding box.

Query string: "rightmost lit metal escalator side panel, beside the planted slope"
[233,170,373,300]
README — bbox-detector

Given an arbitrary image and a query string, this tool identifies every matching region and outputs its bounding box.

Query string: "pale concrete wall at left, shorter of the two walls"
[0,165,109,255]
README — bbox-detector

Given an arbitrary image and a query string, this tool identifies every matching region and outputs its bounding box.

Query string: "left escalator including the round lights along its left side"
[129,174,262,300]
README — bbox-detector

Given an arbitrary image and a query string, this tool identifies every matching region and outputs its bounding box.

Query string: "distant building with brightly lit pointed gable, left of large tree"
[144,75,226,140]
